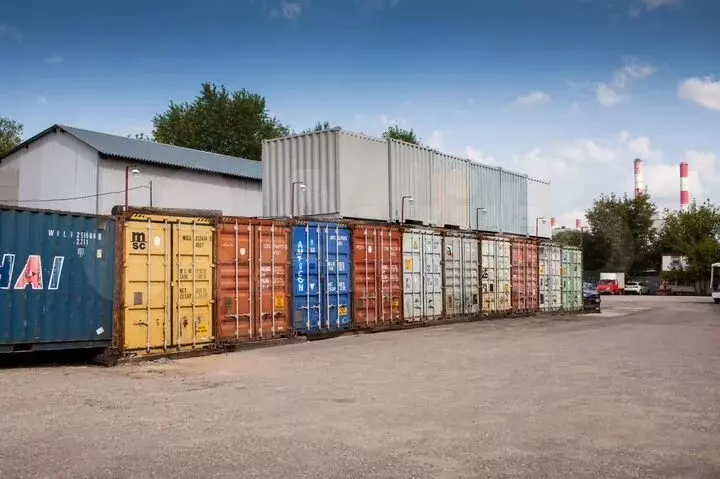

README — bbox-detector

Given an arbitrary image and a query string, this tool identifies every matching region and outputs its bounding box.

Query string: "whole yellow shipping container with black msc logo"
[115,208,218,356]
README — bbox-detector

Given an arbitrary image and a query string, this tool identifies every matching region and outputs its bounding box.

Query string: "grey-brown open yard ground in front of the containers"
[0,297,720,479]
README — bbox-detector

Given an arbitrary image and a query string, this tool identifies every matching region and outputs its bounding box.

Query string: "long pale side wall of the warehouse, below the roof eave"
[99,158,262,216]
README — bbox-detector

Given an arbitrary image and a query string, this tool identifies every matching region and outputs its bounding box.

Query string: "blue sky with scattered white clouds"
[0,0,720,227]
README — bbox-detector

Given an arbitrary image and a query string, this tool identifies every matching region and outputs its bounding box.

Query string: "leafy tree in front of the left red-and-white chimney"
[584,194,657,272]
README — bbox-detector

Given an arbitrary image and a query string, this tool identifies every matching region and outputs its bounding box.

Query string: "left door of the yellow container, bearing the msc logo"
[123,221,172,351]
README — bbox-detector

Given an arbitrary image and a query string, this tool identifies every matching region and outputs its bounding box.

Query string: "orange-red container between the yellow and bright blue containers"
[215,217,292,343]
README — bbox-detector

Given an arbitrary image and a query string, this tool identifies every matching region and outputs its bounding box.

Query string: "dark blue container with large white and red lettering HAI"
[0,207,115,352]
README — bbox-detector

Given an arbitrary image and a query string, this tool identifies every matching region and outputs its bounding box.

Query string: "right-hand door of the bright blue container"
[321,225,352,329]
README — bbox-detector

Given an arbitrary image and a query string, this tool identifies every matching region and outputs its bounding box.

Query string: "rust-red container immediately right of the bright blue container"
[352,224,403,328]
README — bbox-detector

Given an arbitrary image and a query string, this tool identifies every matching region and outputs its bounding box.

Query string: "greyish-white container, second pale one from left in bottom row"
[443,236,480,316]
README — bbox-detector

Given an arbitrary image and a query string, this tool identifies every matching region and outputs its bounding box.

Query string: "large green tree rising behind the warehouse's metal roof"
[153,82,290,160]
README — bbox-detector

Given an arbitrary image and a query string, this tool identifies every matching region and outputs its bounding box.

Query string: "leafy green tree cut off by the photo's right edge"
[657,201,720,290]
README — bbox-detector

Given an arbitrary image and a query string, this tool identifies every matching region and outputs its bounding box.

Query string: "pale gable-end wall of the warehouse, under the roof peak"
[0,132,97,213]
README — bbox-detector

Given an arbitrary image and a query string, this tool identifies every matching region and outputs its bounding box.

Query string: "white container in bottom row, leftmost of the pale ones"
[403,229,443,322]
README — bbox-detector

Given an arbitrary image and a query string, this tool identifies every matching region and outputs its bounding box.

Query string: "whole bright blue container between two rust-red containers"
[293,223,352,334]
